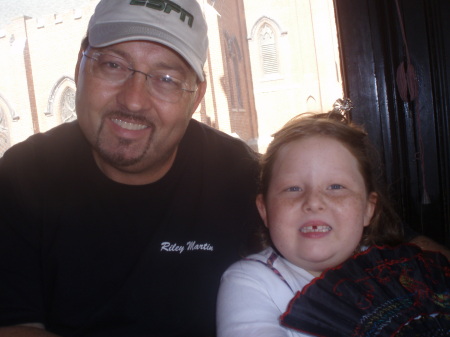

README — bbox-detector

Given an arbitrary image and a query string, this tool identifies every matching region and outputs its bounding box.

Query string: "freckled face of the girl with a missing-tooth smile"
[256,136,377,276]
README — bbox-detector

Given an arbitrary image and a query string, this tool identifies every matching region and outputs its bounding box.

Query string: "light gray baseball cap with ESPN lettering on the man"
[88,0,208,81]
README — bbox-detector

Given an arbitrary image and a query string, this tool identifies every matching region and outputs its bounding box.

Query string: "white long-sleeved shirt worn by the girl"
[217,248,314,337]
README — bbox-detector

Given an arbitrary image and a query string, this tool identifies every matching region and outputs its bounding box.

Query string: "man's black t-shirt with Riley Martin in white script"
[0,120,260,337]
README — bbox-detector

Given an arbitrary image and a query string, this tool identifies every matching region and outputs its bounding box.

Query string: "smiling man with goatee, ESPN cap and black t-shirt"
[0,0,259,337]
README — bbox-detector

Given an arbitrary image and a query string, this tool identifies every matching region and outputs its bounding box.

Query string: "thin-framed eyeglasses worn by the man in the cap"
[83,51,197,103]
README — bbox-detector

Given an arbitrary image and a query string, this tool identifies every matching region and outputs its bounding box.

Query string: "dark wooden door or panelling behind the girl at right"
[335,0,450,247]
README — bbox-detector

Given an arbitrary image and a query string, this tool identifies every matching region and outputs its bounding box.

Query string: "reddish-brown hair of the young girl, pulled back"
[259,111,403,246]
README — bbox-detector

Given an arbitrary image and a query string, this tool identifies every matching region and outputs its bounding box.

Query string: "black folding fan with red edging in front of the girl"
[282,244,450,337]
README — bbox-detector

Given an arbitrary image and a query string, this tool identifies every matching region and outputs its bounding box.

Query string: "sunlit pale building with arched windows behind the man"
[0,0,342,156]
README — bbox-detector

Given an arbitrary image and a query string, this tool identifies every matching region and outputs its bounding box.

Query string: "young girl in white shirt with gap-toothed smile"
[217,112,402,337]
